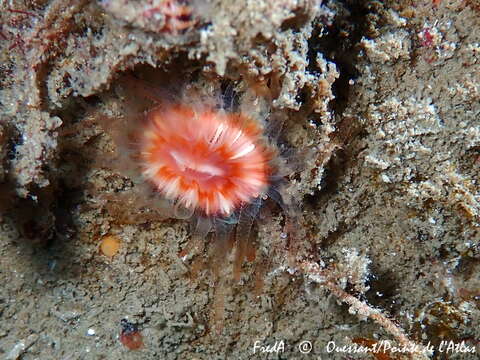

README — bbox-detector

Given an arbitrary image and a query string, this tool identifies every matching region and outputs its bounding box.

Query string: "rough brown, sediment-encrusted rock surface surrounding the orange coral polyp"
[0,0,480,359]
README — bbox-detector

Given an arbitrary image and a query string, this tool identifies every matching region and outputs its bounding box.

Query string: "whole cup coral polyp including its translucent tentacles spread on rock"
[99,74,295,281]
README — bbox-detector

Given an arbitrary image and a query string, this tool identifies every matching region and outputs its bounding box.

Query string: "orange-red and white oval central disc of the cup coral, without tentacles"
[140,105,273,216]
